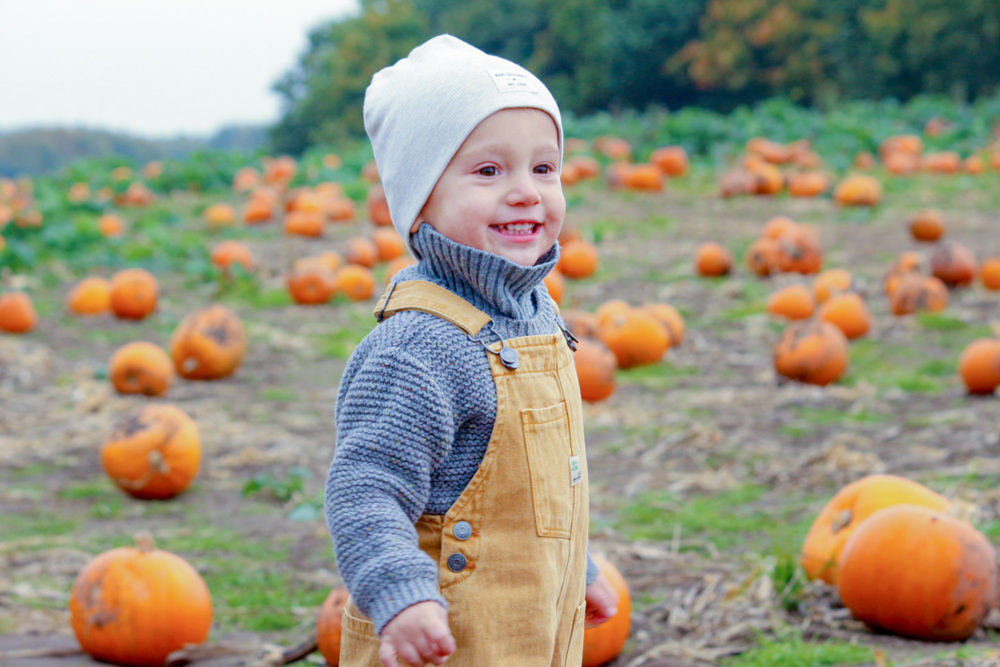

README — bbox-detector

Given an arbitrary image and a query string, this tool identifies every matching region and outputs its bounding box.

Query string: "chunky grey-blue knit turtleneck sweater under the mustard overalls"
[326,224,598,632]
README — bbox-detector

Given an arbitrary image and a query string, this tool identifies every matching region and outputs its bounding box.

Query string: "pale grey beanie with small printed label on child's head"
[364,35,563,254]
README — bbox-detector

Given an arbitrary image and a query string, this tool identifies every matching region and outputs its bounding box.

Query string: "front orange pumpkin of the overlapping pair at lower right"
[838,505,997,641]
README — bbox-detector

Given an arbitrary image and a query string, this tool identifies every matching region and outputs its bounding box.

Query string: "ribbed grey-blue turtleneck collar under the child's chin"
[410,224,559,320]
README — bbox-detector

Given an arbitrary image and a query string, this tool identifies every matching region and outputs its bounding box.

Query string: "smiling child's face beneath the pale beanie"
[414,109,566,266]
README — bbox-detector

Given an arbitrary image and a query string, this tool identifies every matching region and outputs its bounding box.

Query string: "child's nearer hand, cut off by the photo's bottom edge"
[378,601,455,667]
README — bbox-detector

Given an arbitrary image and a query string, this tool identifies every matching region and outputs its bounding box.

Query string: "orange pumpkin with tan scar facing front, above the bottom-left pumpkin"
[101,403,201,500]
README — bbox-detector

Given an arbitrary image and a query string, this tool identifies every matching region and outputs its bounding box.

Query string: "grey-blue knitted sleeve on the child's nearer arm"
[326,347,455,632]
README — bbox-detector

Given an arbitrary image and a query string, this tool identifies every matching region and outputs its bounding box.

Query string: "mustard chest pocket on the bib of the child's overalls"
[521,401,573,539]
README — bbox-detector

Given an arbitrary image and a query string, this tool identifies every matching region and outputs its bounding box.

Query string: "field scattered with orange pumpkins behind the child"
[0,100,1000,667]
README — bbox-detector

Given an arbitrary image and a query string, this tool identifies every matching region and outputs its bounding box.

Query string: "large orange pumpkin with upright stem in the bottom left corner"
[69,535,212,667]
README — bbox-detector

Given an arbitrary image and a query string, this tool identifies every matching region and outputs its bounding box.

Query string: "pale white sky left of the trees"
[0,0,358,138]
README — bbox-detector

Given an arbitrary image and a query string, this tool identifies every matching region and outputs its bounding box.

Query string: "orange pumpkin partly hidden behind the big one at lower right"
[802,475,951,585]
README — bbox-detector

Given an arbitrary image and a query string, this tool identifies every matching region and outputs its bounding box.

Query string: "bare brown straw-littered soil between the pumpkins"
[0,177,1000,667]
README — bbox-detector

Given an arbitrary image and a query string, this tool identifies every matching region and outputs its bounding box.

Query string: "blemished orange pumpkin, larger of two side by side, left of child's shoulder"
[170,304,247,380]
